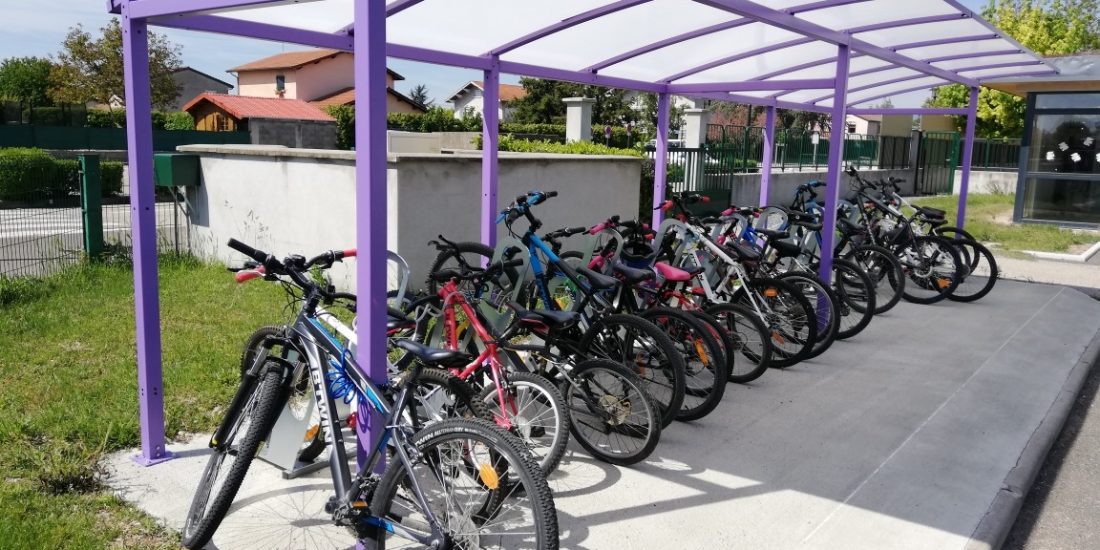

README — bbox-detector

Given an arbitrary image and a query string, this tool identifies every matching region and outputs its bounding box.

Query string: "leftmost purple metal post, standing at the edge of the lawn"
[122,1,172,466]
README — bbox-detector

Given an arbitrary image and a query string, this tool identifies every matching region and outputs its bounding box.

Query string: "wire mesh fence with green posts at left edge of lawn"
[0,156,189,277]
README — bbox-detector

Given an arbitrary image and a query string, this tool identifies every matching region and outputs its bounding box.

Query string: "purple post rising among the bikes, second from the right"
[818,44,849,283]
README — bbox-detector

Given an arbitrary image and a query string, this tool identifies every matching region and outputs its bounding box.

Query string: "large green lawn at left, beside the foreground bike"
[0,259,286,549]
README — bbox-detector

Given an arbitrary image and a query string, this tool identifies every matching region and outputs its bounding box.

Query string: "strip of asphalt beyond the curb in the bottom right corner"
[1003,325,1100,550]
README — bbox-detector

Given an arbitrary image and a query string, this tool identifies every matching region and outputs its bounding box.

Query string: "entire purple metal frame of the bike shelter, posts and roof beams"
[116,0,1056,464]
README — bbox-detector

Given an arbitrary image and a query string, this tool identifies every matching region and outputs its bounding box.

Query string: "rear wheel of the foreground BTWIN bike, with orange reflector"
[363,419,558,550]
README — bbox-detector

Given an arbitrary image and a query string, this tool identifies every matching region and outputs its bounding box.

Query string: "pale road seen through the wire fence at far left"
[0,202,185,276]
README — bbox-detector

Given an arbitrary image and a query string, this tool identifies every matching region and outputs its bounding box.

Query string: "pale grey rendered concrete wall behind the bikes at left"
[180,145,641,288]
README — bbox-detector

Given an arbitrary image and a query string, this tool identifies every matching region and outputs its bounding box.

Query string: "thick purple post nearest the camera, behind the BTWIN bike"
[354,2,386,473]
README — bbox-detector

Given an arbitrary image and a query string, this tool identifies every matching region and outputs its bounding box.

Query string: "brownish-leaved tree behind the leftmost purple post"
[51,19,180,112]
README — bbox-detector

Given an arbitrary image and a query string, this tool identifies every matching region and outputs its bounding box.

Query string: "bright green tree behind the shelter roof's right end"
[925,0,1100,138]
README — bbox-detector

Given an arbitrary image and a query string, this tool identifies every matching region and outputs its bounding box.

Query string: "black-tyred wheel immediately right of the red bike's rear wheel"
[561,359,661,466]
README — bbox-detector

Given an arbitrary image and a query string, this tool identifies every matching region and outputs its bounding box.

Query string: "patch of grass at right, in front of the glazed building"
[914,195,1098,252]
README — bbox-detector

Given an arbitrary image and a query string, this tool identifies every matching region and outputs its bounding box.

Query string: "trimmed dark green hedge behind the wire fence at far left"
[0,149,122,200]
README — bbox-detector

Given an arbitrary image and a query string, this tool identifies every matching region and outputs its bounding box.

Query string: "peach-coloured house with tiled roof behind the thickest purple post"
[229,50,427,112]
